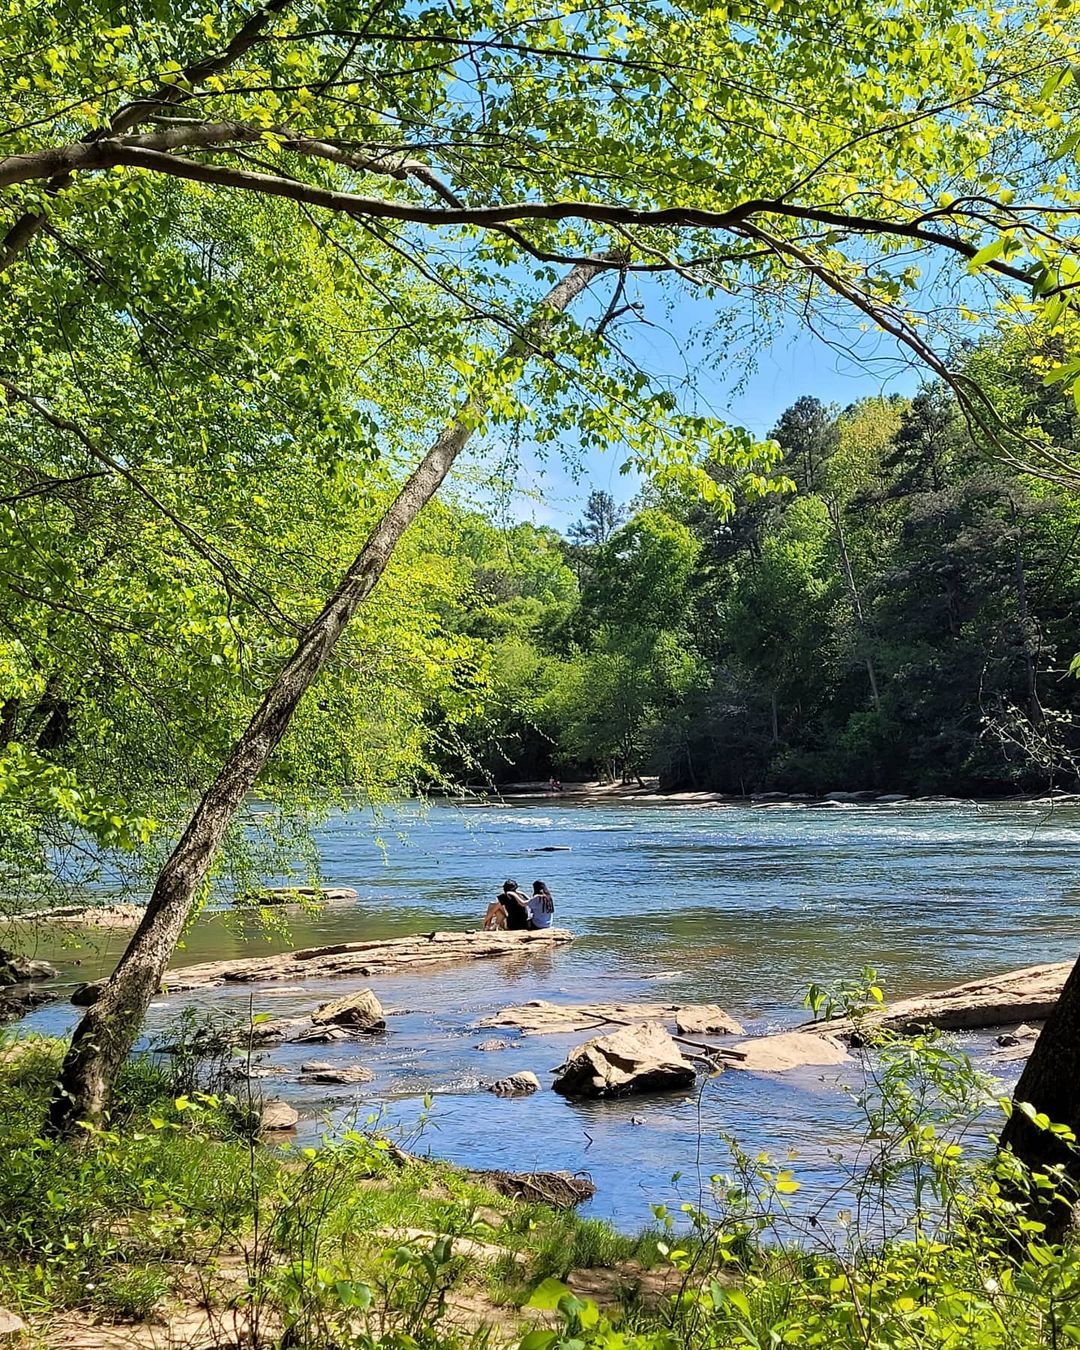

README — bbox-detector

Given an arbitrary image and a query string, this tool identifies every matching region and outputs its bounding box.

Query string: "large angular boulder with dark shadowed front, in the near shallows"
[552,1022,694,1098]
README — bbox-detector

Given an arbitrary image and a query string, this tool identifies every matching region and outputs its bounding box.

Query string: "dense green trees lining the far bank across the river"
[437,338,1080,794]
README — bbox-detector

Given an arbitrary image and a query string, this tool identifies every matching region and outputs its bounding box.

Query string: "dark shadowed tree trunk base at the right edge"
[1000,961,1080,1241]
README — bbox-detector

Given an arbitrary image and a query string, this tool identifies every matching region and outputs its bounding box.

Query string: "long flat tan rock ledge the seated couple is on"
[135,929,574,994]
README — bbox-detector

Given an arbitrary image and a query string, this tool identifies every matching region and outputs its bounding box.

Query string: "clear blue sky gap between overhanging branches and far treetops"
[500,279,926,529]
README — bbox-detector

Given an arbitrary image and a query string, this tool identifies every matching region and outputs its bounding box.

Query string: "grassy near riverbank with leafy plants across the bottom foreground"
[0,1026,1076,1350]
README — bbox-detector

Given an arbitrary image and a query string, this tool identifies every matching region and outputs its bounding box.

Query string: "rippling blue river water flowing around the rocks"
[12,799,1080,1227]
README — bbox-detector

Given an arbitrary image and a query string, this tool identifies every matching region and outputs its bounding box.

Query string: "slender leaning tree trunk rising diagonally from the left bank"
[49,261,603,1135]
